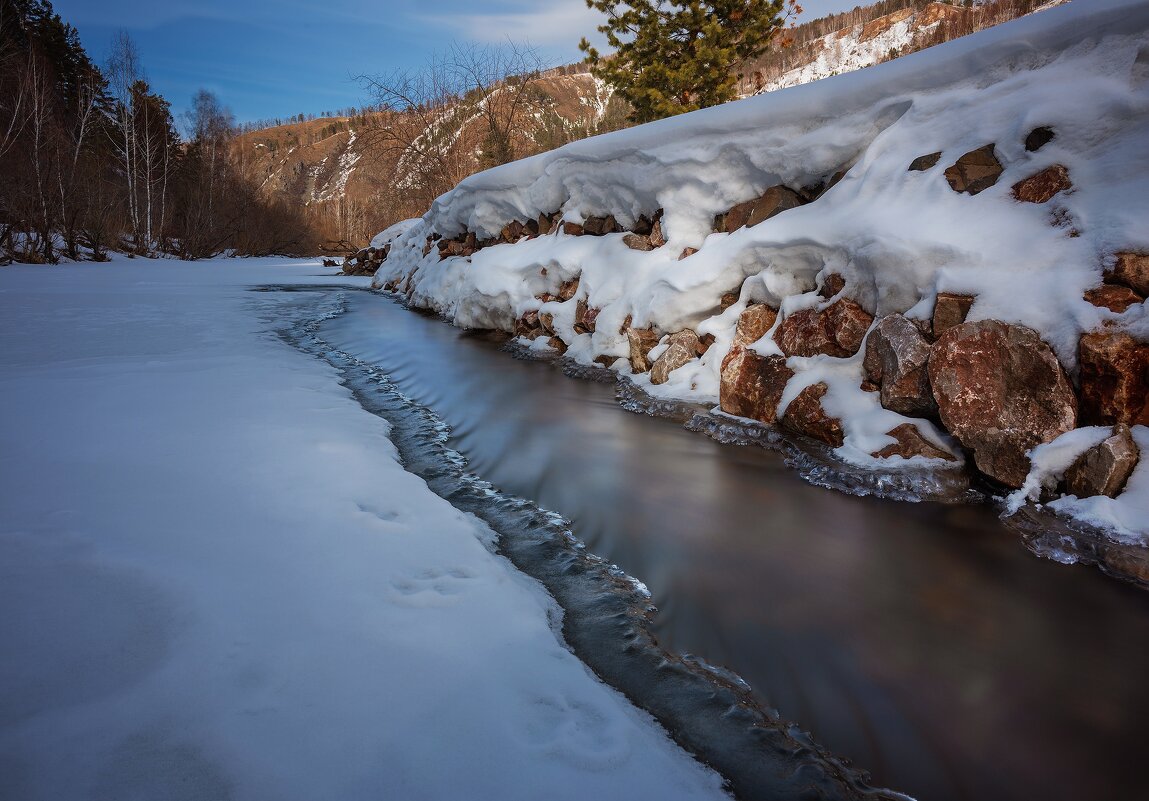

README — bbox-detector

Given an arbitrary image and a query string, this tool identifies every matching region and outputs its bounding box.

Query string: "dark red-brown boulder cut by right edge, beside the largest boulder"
[1078,332,1149,425]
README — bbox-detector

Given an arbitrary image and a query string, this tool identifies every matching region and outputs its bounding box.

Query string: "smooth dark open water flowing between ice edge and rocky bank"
[322,293,1149,801]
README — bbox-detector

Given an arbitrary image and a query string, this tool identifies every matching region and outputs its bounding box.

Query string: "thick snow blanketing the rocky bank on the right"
[375,0,1149,537]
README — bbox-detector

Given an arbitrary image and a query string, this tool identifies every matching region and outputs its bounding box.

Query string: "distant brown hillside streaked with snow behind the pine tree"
[236,0,1061,252]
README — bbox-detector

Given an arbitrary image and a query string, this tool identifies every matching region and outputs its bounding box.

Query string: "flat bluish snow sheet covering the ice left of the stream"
[0,259,725,801]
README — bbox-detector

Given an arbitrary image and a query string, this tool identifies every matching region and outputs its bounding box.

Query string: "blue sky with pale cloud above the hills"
[53,0,858,122]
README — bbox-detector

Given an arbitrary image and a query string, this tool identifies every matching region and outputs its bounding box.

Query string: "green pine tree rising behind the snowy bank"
[579,0,801,123]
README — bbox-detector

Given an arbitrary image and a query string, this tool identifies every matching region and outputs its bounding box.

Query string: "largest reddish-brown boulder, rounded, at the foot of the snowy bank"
[927,319,1077,488]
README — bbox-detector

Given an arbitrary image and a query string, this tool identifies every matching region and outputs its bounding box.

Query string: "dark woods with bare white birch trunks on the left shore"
[0,0,314,263]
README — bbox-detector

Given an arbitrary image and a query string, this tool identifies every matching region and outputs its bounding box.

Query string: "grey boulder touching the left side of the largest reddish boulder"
[862,314,938,417]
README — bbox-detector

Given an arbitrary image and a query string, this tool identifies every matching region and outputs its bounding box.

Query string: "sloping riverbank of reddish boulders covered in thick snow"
[365,2,1149,549]
